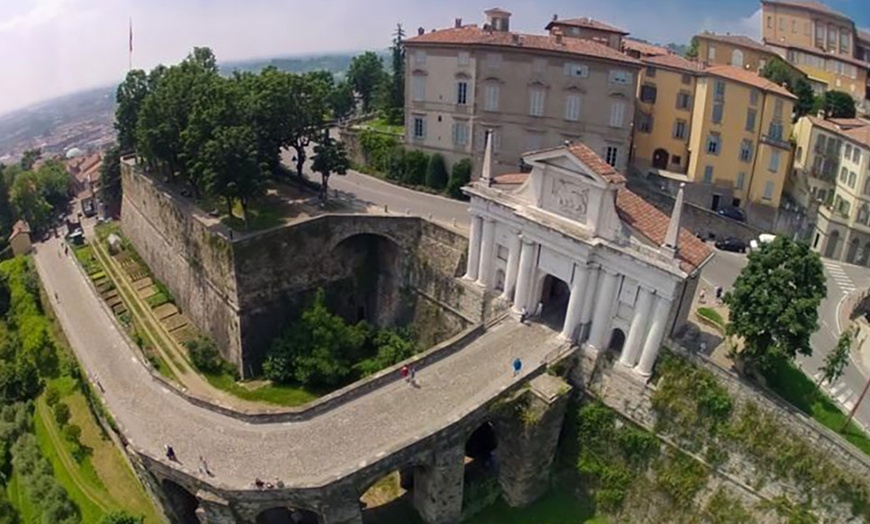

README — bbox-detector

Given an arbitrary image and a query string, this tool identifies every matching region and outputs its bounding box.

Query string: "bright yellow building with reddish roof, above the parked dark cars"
[686,66,795,224]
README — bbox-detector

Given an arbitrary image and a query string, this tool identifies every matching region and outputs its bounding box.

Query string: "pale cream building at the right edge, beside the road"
[812,119,870,266]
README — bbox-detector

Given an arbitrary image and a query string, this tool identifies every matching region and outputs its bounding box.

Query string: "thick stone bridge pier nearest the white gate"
[498,374,571,507]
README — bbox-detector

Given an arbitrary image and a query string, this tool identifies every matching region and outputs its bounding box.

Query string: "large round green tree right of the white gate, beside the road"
[724,236,827,370]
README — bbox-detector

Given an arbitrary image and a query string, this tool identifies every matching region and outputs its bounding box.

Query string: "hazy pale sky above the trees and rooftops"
[0,0,870,115]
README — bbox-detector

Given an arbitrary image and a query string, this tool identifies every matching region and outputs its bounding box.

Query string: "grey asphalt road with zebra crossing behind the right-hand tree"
[701,246,870,429]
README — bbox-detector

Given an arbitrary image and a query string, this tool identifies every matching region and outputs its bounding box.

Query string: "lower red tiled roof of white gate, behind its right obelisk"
[616,188,711,272]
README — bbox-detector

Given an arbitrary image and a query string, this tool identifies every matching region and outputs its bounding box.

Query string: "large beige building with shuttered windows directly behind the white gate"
[405,9,641,174]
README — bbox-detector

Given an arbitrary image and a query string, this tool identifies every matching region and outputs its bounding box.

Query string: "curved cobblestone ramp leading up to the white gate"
[35,239,561,489]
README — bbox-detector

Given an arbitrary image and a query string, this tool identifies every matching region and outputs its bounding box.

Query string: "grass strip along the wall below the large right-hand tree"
[764,362,870,455]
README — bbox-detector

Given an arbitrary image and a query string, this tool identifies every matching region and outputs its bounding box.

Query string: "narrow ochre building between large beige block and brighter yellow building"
[632,54,701,178]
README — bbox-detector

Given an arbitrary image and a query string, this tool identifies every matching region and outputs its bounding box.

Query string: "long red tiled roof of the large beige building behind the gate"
[405,25,640,65]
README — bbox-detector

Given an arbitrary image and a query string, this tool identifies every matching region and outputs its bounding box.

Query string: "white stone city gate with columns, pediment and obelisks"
[465,138,711,377]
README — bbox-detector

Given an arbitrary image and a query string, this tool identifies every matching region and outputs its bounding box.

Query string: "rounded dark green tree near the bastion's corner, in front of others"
[198,126,265,227]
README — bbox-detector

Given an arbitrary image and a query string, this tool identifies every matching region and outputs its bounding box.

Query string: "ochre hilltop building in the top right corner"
[761,0,870,112]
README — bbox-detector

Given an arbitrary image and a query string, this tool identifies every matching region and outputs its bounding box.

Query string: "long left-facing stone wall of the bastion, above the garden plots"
[121,162,242,363]
